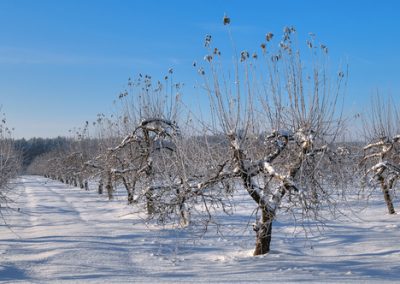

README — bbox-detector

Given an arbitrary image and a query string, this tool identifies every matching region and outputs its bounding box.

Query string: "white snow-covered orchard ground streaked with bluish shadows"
[0,176,400,283]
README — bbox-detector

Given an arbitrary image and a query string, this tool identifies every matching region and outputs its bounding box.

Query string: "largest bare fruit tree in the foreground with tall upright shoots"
[194,20,344,255]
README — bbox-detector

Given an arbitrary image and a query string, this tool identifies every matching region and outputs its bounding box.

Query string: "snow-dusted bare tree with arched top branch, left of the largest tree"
[101,73,197,222]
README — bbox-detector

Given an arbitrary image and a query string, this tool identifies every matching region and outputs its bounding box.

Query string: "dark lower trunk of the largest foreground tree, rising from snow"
[254,209,274,255]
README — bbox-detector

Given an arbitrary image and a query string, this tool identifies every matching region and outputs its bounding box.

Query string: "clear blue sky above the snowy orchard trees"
[0,0,400,138]
